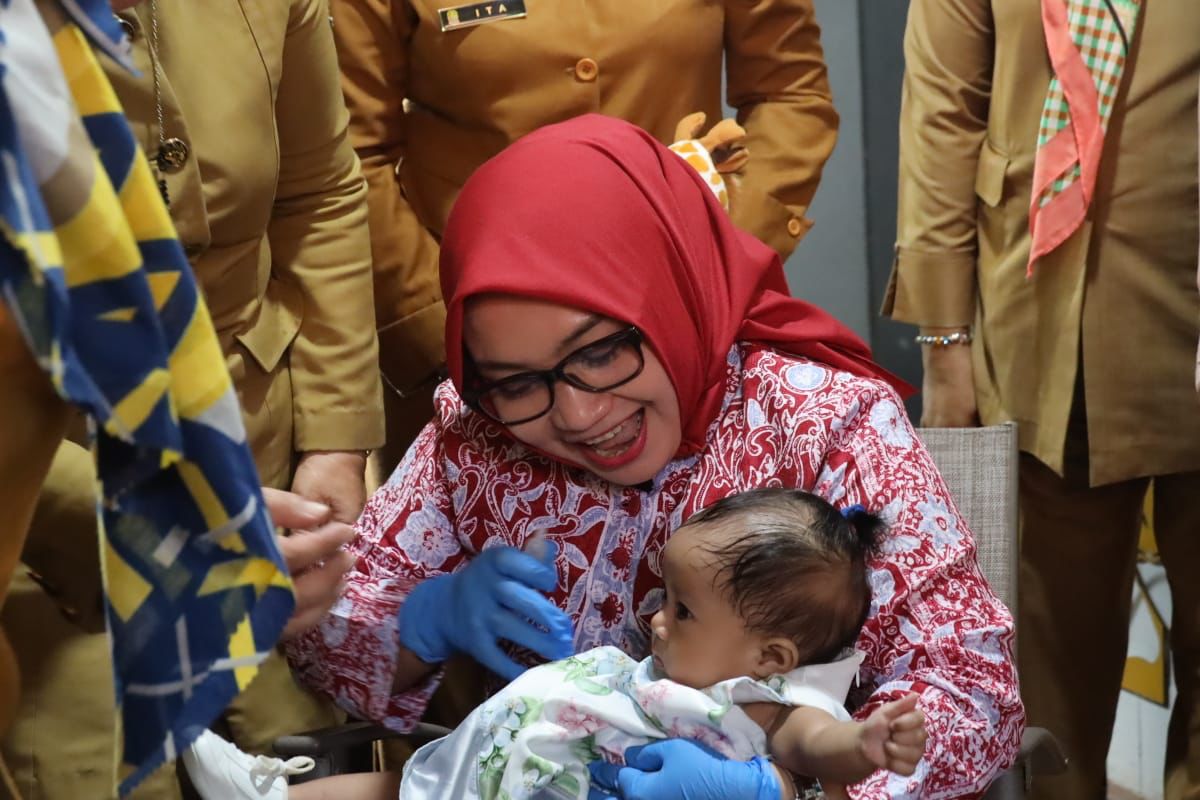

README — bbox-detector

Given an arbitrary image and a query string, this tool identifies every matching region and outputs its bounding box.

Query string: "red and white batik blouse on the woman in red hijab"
[288,344,1024,800]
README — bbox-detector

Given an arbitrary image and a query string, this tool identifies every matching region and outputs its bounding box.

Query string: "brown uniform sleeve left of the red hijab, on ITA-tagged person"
[331,0,445,392]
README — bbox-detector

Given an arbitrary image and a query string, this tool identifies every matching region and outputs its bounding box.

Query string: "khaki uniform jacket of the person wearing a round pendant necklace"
[106,0,383,462]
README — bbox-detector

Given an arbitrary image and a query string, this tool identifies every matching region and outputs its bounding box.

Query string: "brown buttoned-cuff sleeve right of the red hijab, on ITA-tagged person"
[725,0,838,259]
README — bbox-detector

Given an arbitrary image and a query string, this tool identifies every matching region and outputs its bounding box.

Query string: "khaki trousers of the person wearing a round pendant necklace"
[0,342,343,800]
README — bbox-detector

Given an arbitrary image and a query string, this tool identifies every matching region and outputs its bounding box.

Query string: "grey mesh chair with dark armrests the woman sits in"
[275,423,1067,800]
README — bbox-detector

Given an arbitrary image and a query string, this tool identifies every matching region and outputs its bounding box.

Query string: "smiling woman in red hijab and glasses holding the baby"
[289,116,1022,800]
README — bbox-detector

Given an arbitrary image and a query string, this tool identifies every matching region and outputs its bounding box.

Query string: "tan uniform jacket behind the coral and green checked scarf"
[883,0,1200,485]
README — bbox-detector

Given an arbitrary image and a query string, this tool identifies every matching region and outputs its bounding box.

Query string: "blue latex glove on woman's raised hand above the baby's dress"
[400,542,574,680]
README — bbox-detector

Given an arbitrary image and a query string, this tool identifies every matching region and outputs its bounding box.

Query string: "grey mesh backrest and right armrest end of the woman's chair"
[917,422,1067,800]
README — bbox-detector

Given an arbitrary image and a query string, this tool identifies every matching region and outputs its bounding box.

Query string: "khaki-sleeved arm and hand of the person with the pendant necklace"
[268,0,384,522]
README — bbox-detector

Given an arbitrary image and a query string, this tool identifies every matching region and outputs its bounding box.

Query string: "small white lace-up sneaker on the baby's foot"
[184,730,316,800]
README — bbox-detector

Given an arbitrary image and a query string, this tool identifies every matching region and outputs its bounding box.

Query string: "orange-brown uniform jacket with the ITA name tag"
[332,0,838,385]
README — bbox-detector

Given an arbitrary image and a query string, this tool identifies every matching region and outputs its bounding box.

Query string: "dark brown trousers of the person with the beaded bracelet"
[1016,414,1200,800]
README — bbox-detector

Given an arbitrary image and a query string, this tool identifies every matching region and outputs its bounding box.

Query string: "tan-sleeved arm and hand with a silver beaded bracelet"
[883,0,994,427]
